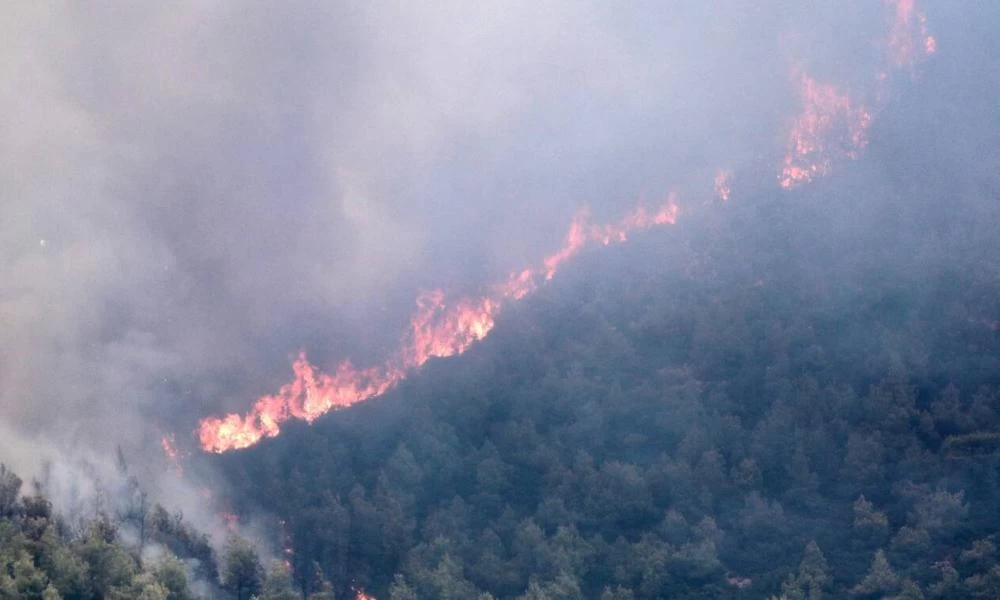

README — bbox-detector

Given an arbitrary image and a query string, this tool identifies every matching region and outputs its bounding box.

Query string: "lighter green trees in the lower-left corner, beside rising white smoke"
[0,464,314,600]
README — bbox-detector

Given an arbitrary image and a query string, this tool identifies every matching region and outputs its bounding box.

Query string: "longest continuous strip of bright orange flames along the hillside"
[198,199,678,453]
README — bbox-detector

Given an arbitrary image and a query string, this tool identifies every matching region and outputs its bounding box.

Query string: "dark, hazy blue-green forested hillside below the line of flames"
[218,154,1000,600]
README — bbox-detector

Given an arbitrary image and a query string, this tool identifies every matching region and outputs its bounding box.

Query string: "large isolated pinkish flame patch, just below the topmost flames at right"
[778,73,872,189]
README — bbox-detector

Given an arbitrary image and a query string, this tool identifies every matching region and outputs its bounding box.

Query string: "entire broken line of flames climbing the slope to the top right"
[197,0,937,452]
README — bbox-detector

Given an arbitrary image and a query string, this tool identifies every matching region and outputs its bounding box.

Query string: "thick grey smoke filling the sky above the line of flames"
[0,0,998,516]
